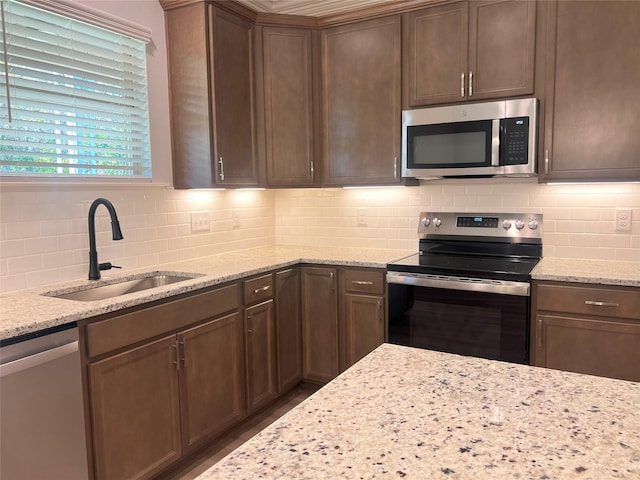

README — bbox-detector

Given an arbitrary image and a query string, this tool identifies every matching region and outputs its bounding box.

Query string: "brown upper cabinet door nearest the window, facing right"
[209,5,259,186]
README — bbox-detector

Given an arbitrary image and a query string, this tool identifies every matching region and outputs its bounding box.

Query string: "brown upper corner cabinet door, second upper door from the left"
[262,27,316,187]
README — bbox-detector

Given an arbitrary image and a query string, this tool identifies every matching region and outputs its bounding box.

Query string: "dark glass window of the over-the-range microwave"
[407,120,492,168]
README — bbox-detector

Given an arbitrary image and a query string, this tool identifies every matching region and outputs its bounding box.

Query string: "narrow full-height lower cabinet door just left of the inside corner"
[275,268,302,392]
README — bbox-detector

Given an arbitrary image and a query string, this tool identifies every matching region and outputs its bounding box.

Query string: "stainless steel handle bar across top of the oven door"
[387,272,530,297]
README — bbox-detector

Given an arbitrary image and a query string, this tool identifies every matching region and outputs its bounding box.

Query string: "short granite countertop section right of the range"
[531,258,640,287]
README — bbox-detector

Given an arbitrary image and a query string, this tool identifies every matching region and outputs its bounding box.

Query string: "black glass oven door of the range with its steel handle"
[387,272,530,364]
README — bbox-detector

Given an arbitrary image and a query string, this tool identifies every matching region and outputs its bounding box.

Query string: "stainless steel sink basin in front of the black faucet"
[44,273,198,302]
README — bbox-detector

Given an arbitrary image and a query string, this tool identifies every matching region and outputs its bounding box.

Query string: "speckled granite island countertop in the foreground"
[198,344,640,480]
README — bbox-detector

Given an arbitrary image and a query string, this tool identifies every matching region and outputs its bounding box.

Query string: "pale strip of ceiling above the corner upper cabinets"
[238,0,394,17]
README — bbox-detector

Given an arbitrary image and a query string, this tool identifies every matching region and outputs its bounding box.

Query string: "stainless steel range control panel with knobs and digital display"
[418,212,542,239]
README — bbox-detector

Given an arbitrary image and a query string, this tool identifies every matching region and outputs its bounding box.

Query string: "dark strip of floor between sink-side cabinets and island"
[159,383,320,480]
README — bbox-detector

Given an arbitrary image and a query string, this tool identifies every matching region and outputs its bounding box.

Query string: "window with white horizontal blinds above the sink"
[0,0,151,180]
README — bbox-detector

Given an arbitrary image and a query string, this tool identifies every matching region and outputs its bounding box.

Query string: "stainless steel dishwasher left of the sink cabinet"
[0,326,89,480]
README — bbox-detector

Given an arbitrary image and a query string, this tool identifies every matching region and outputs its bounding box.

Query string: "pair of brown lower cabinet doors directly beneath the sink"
[88,313,245,480]
